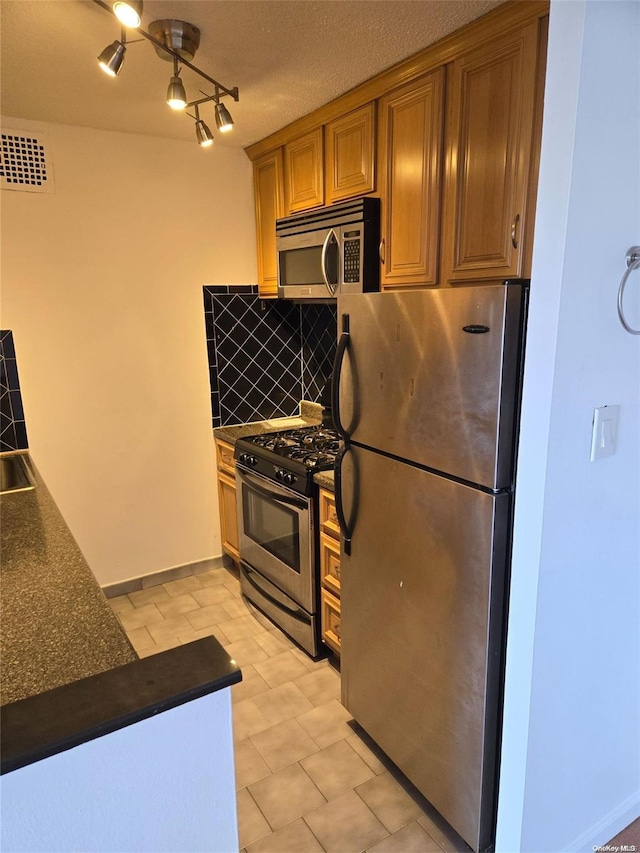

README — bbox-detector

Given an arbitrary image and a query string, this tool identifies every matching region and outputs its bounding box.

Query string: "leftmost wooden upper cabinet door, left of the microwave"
[253,148,284,297]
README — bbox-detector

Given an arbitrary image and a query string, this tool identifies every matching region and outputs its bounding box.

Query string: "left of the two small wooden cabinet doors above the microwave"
[284,127,324,213]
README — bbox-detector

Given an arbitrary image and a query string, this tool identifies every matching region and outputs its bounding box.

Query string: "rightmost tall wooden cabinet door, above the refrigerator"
[443,22,538,282]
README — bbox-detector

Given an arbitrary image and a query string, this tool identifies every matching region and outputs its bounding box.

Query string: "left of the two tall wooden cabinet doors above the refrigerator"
[378,69,444,288]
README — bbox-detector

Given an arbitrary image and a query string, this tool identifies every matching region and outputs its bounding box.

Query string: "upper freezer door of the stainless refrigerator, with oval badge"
[334,284,524,489]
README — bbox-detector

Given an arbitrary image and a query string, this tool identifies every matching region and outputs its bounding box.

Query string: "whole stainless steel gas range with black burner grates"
[234,425,339,657]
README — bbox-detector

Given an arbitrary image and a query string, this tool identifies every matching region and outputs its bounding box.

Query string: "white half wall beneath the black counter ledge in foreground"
[0,688,238,853]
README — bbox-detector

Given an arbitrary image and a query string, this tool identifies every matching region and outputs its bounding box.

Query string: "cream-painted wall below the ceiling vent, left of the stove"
[1,118,257,585]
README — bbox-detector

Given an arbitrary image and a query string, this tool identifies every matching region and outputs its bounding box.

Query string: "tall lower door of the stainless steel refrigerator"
[341,447,510,850]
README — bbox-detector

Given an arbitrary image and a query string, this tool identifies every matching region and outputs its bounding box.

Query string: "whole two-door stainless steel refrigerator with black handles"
[333,281,528,850]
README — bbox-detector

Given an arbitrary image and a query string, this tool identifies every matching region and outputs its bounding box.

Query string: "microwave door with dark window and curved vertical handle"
[276,228,341,299]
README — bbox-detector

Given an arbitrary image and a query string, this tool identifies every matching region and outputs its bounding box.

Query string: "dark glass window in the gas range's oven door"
[242,486,300,574]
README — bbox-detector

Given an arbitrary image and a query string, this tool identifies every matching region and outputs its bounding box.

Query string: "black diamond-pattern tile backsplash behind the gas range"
[204,285,336,427]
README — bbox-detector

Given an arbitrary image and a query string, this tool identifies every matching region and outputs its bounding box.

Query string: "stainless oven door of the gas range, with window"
[236,465,315,613]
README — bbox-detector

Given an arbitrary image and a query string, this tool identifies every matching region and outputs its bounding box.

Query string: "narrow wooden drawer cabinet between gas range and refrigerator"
[320,489,340,655]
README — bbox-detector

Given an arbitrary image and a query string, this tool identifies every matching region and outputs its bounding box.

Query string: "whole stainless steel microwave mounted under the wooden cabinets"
[276,198,380,301]
